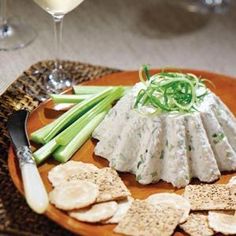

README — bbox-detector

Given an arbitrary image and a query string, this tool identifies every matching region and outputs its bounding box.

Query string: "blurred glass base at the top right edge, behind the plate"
[181,0,230,14]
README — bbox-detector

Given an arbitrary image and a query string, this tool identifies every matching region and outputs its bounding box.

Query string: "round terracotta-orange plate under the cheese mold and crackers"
[8,69,236,235]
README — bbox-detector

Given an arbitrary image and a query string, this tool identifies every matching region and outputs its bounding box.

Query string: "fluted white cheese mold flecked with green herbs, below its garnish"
[93,83,236,188]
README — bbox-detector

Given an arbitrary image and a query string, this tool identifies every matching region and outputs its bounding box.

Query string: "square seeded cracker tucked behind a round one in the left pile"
[68,167,131,202]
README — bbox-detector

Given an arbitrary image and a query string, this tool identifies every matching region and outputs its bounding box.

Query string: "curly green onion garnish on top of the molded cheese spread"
[134,65,208,114]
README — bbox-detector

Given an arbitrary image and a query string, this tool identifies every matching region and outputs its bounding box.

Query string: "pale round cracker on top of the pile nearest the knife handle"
[49,181,99,210]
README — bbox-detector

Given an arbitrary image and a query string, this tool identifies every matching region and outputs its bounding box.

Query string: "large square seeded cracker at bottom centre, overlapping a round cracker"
[114,200,181,236]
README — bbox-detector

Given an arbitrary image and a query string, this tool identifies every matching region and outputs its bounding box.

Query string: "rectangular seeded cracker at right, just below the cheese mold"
[183,184,236,211]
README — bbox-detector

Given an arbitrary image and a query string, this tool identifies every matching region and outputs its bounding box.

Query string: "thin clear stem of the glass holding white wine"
[53,15,64,71]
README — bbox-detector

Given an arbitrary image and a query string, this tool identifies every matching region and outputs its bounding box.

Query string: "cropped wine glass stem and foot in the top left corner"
[0,0,37,51]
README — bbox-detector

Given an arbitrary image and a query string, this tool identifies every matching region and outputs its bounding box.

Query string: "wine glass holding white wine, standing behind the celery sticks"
[34,0,83,93]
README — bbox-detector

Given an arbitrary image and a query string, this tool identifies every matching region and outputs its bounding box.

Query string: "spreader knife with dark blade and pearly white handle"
[7,110,49,214]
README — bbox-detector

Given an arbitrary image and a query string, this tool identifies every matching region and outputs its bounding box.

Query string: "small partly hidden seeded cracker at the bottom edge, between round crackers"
[180,212,214,236]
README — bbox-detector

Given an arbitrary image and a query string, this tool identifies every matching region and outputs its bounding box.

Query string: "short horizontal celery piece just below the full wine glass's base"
[50,94,91,103]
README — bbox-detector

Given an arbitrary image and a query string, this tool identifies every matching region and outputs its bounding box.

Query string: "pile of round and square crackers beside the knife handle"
[48,161,132,223]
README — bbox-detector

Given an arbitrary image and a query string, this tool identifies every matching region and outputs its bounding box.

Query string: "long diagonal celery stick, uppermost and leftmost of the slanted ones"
[31,88,113,144]
